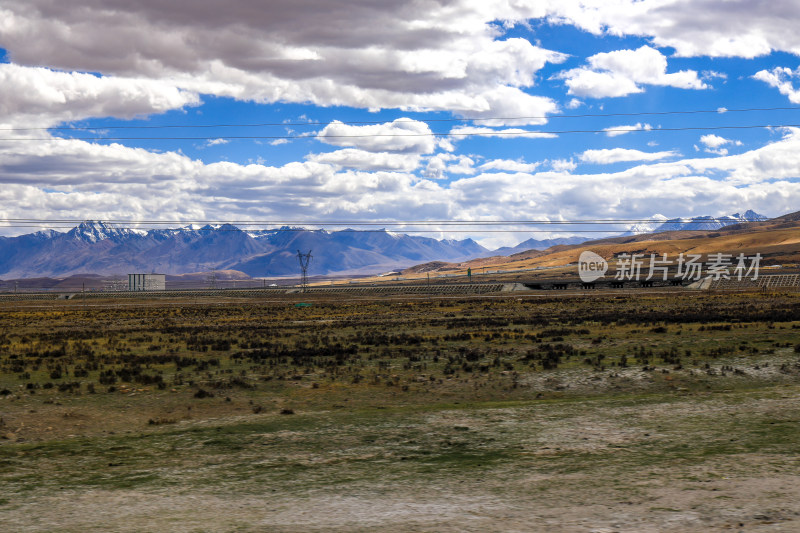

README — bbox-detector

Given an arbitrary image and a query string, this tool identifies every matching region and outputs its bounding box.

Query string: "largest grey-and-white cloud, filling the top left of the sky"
[0,0,567,125]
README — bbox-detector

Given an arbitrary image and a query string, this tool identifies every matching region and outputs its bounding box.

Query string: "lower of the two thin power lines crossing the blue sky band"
[0,124,800,142]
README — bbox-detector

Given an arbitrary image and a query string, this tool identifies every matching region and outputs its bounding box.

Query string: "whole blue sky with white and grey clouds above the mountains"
[0,0,800,248]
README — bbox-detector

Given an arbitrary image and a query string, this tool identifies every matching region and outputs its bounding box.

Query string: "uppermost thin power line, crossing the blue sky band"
[0,107,800,131]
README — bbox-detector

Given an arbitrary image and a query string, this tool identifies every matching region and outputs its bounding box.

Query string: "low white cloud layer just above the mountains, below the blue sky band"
[0,123,800,244]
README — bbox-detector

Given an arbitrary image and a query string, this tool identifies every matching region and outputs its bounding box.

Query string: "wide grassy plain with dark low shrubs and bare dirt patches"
[0,290,800,531]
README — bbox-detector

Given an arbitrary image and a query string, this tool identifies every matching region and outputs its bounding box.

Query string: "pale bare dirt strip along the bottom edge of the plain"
[3,476,800,533]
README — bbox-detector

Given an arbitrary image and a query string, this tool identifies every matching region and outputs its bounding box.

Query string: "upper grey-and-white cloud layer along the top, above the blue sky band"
[0,0,800,120]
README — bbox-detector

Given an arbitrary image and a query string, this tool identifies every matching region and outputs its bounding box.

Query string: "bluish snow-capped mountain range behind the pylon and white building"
[0,221,488,279]
